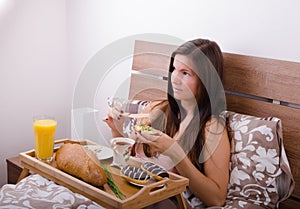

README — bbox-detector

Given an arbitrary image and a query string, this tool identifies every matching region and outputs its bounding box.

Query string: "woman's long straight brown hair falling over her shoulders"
[155,39,226,171]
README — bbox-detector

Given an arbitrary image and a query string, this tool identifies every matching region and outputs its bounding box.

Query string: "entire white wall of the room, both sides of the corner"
[0,0,300,185]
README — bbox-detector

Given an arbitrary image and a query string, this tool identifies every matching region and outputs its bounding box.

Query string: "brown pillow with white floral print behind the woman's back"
[225,111,294,208]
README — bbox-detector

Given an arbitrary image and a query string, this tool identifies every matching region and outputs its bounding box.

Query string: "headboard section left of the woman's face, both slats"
[129,40,172,100]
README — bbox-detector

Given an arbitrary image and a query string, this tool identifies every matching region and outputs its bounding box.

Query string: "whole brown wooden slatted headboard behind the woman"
[129,41,300,208]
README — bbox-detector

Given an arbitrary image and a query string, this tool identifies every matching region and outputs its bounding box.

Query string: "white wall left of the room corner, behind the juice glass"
[0,0,71,186]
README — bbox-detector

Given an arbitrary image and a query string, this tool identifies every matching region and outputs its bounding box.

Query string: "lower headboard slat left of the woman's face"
[129,74,168,100]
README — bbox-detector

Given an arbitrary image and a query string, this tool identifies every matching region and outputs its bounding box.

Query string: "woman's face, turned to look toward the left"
[171,54,200,101]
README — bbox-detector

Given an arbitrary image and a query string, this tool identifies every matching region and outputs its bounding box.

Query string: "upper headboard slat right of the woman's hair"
[223,53,300,104]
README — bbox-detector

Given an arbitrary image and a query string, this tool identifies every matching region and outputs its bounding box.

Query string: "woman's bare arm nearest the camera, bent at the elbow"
[176,125,230,206]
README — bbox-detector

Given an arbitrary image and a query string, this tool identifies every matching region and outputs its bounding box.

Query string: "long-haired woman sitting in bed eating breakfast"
[106,39,230,208]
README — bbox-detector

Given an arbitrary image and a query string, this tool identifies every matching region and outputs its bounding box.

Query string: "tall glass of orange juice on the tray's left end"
[33,116,57,163]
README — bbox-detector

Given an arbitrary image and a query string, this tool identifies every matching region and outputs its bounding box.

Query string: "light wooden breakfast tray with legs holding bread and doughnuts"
[18,139,189,209]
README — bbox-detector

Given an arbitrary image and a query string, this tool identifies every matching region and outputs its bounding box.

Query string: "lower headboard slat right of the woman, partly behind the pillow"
[226,95,300,199]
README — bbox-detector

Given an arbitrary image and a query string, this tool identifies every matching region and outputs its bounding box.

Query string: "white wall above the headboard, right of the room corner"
[67,0,300,62]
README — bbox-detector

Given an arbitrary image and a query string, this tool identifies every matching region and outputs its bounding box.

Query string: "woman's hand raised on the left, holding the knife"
[102,107,124,137]
